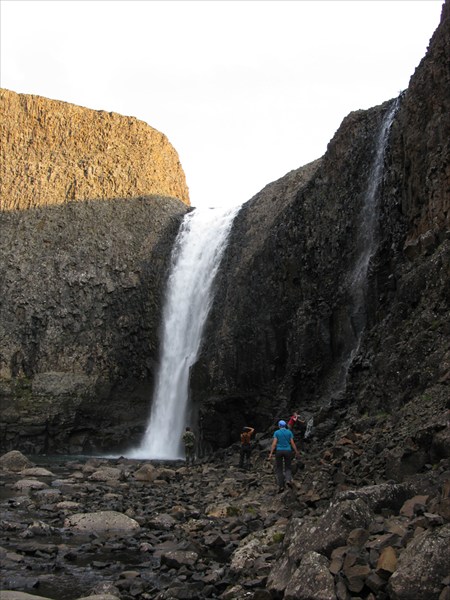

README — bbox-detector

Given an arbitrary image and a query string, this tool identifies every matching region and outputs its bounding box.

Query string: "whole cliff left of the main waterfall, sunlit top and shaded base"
[0,90,189,453]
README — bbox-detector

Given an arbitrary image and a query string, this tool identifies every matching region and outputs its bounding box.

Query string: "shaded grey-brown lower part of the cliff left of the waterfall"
[0,197,187,454]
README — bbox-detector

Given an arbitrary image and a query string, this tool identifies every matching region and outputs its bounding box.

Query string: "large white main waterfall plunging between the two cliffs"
[127,207,240,460]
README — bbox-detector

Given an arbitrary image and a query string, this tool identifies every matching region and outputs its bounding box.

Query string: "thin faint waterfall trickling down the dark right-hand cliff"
[334,98,400,395]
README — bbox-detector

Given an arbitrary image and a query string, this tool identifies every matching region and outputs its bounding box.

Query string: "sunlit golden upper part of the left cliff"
[0,89,189,210]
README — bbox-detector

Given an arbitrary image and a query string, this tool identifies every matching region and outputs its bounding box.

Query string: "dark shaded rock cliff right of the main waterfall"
[192,2,450,446]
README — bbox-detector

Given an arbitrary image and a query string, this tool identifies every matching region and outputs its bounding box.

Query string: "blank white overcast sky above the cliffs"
[0,0,443,206]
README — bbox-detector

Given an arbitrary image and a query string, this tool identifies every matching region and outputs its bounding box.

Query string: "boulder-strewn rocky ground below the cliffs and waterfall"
[0,399,450,600]
